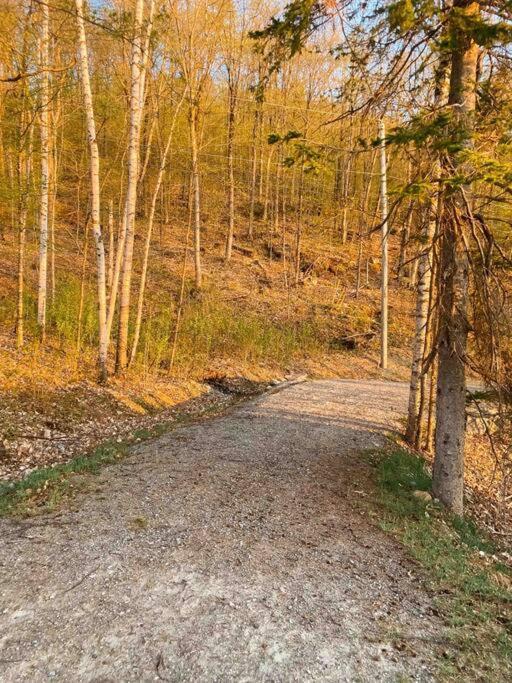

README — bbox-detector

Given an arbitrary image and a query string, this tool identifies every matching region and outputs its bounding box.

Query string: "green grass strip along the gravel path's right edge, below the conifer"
[371,449,512,681]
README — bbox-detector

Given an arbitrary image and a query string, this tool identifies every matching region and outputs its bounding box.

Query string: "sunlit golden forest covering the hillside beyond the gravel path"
[0,0,512,560]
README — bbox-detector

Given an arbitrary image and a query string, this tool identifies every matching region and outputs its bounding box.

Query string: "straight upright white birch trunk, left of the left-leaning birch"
[37,4,50,341]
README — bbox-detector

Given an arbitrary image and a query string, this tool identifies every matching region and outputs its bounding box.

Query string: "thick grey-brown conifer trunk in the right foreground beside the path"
[433,0,480,515]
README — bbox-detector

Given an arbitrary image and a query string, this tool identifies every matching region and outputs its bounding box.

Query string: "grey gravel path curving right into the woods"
[0,381,442,683]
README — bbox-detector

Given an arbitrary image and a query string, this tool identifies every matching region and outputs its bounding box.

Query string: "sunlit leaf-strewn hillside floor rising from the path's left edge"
[0,224,412,478]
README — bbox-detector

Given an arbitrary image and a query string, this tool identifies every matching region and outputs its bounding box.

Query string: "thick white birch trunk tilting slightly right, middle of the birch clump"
[116,0,144,374]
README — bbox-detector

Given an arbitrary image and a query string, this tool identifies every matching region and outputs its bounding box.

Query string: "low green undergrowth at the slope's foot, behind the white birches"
[0,276,332,375]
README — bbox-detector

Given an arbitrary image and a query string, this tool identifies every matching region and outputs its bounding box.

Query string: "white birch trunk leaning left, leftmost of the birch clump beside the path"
[75,0,108,382]
